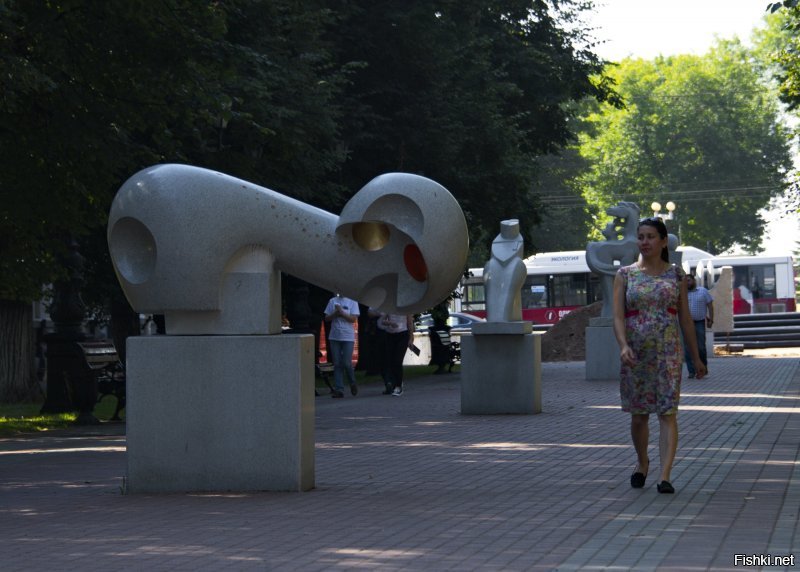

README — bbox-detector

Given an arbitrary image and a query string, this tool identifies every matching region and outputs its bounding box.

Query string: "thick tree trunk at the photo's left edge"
[0,300,41,403]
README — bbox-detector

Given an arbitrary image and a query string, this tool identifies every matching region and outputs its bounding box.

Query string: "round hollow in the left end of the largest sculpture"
[108,217,156,284]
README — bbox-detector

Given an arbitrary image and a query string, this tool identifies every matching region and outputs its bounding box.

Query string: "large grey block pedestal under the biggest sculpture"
[126,335,314,493]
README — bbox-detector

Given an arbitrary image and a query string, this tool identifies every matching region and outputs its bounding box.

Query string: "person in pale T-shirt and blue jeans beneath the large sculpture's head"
[325,293,360,398]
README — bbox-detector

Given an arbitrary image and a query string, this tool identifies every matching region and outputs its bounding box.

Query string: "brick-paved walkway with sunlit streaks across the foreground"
[0,354,800,571]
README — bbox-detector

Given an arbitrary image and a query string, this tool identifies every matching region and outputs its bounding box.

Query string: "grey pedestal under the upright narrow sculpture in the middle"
[461,333,542,415]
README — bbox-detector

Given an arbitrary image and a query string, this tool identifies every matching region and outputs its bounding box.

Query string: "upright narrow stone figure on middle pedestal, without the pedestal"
[483,219,527,322]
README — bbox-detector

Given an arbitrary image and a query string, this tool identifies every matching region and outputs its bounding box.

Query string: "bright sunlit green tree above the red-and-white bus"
[580,45,791,251]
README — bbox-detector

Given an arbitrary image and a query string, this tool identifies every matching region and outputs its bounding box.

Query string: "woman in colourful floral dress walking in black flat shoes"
[614,218,706,493]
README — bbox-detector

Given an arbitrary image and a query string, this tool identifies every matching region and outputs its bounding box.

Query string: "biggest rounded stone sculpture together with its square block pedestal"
[108,165,469,493]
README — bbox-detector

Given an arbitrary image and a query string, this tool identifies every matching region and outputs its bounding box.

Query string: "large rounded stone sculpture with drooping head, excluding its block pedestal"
[108,165,469,334]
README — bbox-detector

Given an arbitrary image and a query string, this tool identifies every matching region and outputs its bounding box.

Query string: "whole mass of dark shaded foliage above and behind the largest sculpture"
[0,0,614,402]
